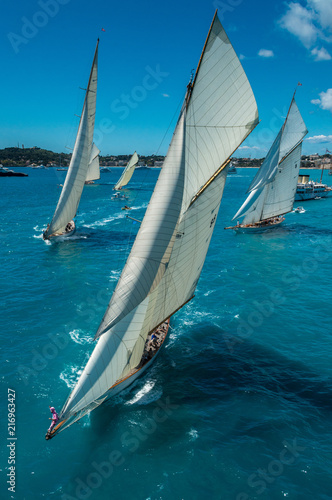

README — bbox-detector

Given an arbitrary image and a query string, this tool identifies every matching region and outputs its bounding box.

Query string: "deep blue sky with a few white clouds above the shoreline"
[0,0,332,158]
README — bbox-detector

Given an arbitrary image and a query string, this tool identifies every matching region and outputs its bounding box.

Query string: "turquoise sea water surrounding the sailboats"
[0,169,332,500]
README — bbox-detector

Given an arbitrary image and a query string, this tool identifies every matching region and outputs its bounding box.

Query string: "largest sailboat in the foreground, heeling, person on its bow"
[46,13,258,439]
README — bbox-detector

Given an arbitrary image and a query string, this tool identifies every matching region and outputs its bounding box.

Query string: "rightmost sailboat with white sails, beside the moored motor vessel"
[225,91,308,233]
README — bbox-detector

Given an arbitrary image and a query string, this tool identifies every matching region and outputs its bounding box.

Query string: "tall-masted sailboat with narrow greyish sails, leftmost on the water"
[43,39,99,240]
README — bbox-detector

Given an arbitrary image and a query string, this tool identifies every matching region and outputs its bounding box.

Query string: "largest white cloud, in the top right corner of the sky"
[279,0,332,61]
